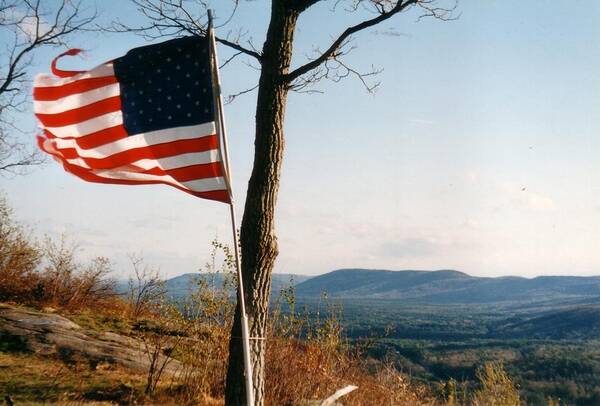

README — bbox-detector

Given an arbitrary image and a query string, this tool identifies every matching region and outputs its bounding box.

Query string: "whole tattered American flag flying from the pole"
[33,37,230,202]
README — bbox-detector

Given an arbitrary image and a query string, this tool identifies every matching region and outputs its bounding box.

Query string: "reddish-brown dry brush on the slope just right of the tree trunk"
[266,339,435,406]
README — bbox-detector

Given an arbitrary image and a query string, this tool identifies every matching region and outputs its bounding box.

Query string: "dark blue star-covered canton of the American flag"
[114,37,214,135]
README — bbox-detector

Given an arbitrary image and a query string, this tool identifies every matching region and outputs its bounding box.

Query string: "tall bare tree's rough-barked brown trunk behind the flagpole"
[225,0,299,406]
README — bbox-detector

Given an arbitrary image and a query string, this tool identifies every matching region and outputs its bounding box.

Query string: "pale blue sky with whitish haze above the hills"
[0,0,600,277]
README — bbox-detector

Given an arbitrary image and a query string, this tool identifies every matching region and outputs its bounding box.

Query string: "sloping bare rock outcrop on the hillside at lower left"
[0,306,181,373]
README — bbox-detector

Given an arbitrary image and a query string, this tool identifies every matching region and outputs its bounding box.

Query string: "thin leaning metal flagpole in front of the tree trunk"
[208,10,254,406]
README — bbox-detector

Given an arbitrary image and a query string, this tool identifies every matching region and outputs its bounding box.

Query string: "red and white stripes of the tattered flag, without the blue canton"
[33,49,230,202]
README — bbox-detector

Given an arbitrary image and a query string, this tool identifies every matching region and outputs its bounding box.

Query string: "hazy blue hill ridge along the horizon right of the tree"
[295,269,600,304]
